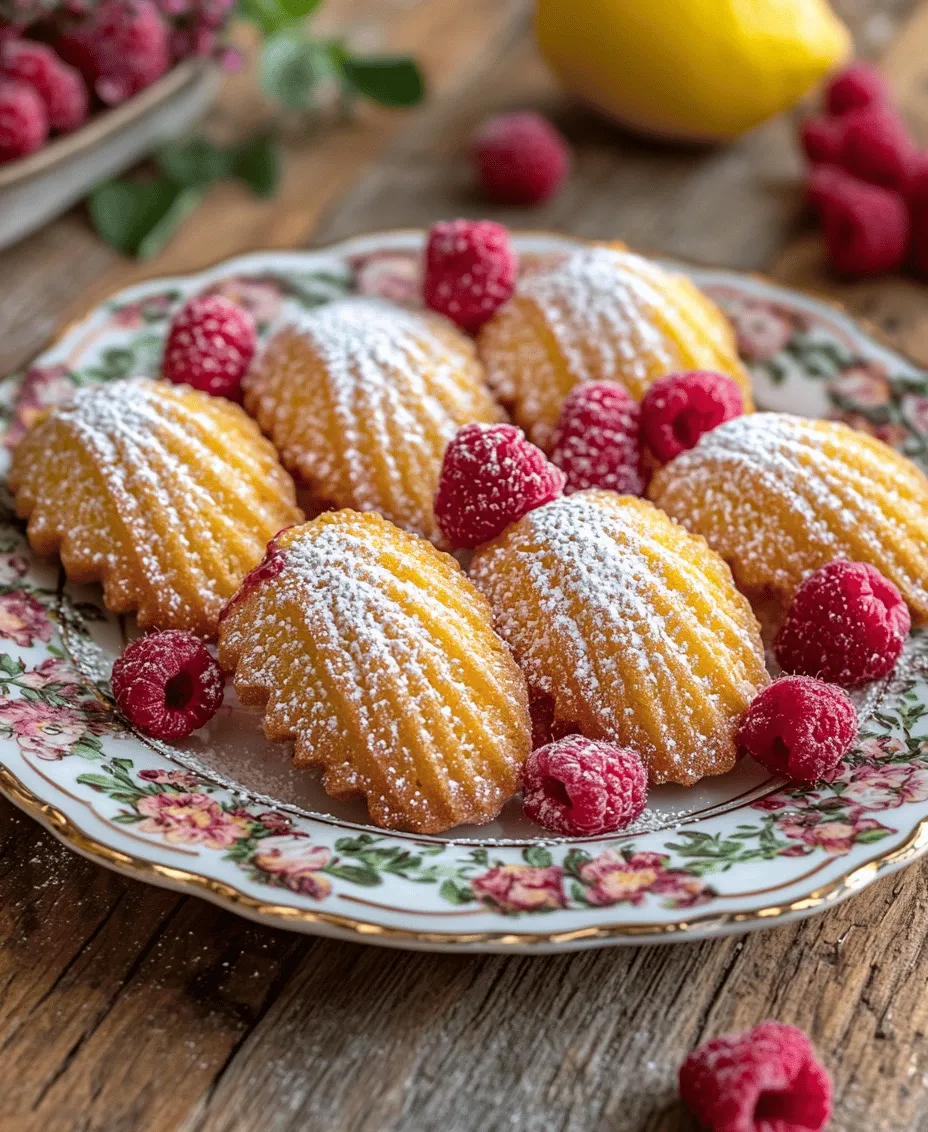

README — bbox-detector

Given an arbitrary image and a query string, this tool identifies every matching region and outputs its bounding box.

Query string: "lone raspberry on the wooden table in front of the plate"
[680,1021,832,1132]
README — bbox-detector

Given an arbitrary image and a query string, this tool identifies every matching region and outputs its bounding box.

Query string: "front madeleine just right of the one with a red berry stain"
[471,491,767,786]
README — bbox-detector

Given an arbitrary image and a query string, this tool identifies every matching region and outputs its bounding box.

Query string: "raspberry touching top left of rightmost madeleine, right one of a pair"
[642,369,745,464]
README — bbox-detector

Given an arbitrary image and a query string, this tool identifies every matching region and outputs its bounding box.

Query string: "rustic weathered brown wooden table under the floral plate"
[0,0,928,1132]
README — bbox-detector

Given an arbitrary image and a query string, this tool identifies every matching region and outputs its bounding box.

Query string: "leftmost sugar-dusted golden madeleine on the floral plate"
[9,378,303,636]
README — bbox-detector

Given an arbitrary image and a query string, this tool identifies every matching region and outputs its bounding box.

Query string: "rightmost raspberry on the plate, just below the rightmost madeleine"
[773,561,912,688]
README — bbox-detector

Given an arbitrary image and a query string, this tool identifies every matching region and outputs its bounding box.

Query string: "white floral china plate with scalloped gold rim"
[0,232,928,951]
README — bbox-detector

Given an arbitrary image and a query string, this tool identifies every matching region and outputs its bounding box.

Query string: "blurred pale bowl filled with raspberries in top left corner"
[0,0,222,248]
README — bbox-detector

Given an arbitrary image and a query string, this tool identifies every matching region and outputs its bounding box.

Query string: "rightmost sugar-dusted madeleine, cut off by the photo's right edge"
[650,413,928,623]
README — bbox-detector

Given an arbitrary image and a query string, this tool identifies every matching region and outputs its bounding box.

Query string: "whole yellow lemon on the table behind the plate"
[535,0,851,140]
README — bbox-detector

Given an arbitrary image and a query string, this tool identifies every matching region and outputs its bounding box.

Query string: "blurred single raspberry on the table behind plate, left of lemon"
[473,110,570,205]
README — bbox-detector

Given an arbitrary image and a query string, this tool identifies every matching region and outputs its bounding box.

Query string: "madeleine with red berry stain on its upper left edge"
[220,511,531,833]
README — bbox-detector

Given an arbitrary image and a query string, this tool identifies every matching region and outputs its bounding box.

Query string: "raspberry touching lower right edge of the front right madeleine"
[738,676,857,782]
